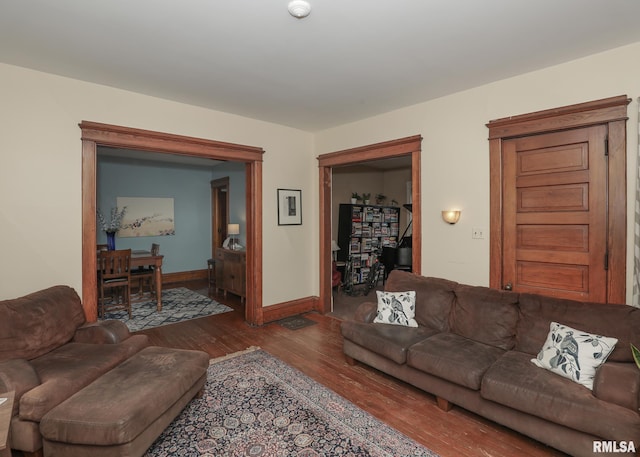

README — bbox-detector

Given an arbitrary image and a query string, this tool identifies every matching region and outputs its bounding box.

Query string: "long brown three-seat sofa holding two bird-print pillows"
[341,270,640,456]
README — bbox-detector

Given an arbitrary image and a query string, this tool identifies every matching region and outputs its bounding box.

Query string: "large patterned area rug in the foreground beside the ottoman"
[145,348,436,457]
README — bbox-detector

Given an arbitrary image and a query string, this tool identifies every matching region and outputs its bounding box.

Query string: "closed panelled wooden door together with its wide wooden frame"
[487,96,630,303]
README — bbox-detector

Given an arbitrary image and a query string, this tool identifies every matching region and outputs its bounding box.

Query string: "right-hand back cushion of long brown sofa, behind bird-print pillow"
[515,294,640,362]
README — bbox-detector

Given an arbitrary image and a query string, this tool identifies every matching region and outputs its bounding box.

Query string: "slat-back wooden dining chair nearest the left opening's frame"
[98,249,131,318]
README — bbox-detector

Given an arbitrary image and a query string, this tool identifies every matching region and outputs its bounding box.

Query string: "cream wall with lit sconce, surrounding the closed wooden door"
[315,43,640,300]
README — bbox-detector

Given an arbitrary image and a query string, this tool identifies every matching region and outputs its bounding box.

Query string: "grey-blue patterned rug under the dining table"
[104,287,233,332]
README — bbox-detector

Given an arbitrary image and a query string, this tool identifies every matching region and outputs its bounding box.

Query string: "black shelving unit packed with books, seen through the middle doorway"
[337,203,400,284]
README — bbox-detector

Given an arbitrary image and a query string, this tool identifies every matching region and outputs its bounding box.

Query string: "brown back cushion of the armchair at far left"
[0,286,85,361]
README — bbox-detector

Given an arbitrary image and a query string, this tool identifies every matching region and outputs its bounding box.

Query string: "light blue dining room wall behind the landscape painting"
[97,154,246,273]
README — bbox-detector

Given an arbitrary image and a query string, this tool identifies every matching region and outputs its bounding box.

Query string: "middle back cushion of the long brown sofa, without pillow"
[450,285,520,350]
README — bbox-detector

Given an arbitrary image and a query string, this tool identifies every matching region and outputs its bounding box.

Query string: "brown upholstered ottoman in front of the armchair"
[40,347,209,457]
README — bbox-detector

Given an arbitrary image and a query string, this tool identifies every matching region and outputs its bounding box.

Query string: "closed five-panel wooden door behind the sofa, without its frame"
[502,125,607,302]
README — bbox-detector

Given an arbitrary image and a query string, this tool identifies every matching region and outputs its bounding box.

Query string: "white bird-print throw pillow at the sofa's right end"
[531,322,618,390]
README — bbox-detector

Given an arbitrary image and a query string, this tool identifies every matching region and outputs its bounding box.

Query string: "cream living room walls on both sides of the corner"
[0,43,640,305]
